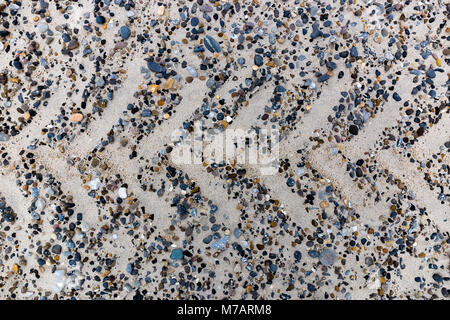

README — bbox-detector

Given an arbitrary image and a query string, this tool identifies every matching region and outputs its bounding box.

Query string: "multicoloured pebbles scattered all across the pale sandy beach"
[0,0,450,300]
